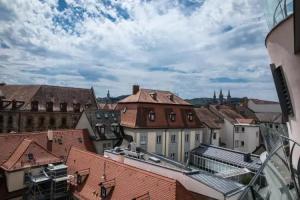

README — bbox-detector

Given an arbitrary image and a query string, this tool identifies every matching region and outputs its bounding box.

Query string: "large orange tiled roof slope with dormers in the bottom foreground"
[67,148,194,200]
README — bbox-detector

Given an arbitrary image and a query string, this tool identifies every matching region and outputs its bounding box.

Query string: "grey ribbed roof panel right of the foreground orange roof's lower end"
[188,172,245,195]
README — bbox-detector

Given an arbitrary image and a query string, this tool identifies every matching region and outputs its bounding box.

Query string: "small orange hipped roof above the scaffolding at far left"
[1,139,62,171]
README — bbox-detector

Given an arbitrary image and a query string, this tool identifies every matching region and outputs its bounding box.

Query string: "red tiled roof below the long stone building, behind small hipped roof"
[0,130,95,164]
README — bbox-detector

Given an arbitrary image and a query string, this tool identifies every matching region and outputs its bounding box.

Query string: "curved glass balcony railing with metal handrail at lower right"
[239,127,300,200]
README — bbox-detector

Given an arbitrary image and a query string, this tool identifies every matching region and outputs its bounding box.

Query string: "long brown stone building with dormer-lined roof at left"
[0,84,97,133]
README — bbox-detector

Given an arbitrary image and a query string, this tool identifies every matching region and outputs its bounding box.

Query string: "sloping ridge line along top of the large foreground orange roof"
[67,146,176,183]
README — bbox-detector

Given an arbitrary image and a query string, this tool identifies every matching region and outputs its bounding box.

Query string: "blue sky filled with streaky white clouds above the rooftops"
[0,0,277,100]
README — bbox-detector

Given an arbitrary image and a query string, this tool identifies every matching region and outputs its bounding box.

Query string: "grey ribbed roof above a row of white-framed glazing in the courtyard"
[192,144,261,171]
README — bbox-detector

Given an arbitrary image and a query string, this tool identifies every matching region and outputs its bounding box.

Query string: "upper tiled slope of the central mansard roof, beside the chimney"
[119,89,191,105]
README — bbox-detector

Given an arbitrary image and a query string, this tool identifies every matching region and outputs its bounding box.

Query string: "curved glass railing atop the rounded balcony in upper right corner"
[264,0,294,29]
